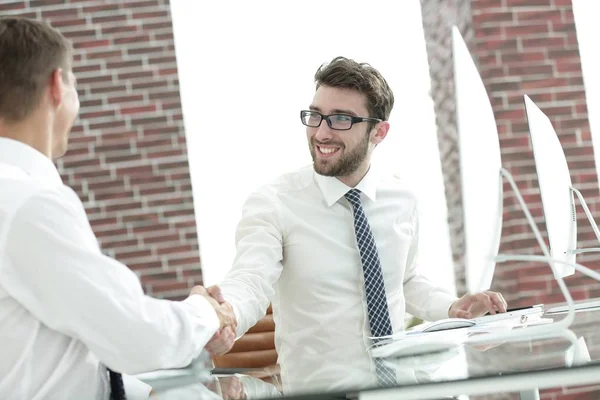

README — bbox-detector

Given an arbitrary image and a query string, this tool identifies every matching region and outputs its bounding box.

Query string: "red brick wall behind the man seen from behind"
[0,0,202,298]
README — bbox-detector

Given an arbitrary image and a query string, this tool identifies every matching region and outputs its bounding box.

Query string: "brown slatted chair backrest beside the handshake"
[213,307,277,368]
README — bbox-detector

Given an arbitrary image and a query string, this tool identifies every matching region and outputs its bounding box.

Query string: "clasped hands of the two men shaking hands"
[190,286,237,356]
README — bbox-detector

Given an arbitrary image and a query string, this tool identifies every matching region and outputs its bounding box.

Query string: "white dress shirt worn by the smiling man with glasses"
[219,166,456,393]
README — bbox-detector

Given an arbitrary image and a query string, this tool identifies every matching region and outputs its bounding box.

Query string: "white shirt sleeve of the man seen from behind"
[0,186,219,374]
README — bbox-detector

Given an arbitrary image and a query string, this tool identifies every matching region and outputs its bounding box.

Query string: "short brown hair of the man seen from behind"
[0,17,73,122]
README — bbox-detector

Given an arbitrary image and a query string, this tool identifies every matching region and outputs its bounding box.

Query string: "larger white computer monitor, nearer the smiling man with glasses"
[452,26,502,292]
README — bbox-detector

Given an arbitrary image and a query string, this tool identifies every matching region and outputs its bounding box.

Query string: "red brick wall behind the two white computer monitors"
[472,0,600,310]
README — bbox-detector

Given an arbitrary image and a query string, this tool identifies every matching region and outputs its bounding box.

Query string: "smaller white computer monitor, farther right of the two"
[524,95,577,277]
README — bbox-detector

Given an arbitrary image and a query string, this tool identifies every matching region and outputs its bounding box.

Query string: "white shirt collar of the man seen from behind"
[0,137,62,183]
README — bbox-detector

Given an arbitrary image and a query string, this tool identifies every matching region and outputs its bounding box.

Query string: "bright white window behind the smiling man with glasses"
[171,0,454,290]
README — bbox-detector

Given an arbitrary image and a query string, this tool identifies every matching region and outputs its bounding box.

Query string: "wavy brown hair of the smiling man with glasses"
[315,57,394,121]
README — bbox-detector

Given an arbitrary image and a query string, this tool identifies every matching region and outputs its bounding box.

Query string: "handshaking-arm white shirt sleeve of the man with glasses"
[218,193,283,337]
